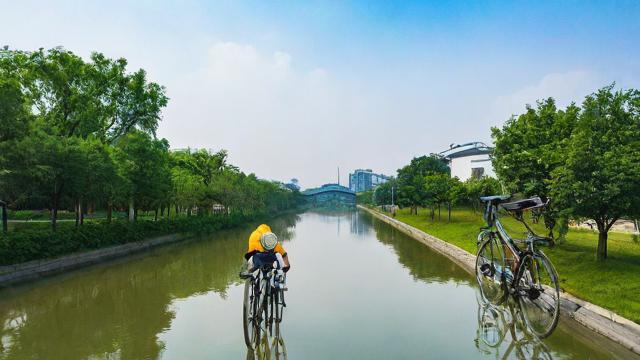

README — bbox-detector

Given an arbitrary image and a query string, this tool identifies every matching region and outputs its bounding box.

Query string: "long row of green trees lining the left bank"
[0,48,297,229]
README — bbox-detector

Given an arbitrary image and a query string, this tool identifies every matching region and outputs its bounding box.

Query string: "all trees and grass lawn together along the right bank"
[359,85,640,323]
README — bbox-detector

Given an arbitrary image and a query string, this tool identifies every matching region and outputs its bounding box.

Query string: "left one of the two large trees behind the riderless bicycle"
[492,98,580,236]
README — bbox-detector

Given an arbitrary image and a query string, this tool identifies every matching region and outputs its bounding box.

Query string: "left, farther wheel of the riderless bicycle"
[476,236,508,305]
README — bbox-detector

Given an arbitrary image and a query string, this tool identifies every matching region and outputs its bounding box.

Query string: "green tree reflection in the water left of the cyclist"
[0,215,299,360]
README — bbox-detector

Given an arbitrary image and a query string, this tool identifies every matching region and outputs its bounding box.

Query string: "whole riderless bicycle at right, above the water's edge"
[476,195,560,338]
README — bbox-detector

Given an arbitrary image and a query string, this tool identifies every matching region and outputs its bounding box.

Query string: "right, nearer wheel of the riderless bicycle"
[516,251,560,338]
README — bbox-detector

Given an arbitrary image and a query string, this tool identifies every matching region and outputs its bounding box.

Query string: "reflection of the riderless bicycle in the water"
[475,294,553,359]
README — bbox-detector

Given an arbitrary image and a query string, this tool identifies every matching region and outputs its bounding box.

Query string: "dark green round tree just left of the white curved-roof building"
[398,154,450,214]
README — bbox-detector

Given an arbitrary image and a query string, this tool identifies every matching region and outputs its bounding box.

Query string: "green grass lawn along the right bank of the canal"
[396,205,640,323]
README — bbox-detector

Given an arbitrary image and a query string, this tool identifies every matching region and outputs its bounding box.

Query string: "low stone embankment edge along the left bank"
[0,234,193,288]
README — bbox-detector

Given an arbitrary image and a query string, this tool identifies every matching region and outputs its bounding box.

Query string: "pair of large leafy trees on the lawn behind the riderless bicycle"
[492,85,640,260]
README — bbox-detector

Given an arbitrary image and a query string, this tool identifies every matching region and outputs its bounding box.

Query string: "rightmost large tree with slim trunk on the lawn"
[552,85,640,260]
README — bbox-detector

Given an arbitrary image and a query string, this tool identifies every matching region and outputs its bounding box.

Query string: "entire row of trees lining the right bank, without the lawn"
[371,85,640,260]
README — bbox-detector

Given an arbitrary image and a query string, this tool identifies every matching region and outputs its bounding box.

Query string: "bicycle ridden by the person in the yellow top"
[242,261,287,359]
